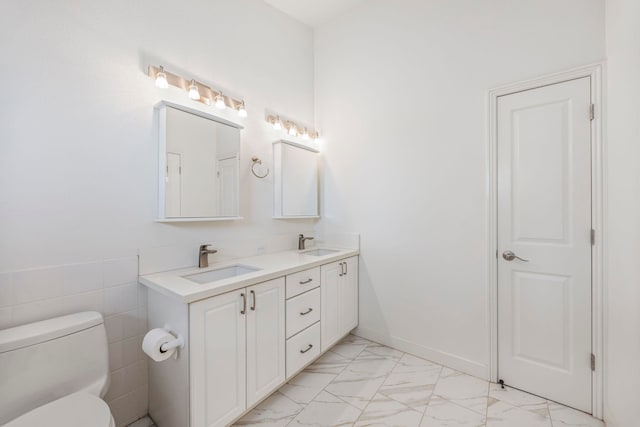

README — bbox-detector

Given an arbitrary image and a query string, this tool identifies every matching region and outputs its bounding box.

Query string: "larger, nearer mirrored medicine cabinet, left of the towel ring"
[156,101,242,222]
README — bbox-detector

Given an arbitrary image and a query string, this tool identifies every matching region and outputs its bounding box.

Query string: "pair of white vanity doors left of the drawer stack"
[189,278,285,427]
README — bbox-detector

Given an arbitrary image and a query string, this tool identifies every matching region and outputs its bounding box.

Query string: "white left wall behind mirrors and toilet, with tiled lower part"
[0,0,314,425]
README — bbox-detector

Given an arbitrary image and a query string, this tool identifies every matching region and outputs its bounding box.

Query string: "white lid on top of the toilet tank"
[0,311,103,353]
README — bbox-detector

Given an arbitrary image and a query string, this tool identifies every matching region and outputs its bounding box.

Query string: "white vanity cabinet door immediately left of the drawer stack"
[247,277,286,406]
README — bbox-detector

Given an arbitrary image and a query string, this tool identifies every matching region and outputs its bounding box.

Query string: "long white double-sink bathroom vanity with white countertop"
[140,248,358,427]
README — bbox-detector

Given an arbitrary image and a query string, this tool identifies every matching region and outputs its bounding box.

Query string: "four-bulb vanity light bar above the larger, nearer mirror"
[148,65,247,117]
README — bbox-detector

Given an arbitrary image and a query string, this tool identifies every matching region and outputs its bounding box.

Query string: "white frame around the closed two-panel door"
[486,62,606,419]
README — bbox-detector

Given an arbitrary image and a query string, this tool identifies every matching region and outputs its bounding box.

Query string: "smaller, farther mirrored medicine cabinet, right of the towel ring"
[273,140,319,219]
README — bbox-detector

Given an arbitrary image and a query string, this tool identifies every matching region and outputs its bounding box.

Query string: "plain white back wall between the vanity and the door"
[315,0,604,376]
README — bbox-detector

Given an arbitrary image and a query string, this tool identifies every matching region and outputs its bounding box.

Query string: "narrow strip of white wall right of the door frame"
[605,0,640,427]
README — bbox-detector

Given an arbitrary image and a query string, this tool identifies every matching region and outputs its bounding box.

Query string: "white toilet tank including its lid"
[0,311,109,425]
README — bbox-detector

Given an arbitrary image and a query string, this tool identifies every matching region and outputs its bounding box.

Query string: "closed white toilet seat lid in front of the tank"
[3,392,115,427]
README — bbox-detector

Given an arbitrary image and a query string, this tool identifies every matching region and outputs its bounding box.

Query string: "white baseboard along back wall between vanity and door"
[352,326,489,380]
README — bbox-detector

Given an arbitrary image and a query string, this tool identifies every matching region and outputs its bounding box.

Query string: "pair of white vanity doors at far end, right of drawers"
[320,257,358,352]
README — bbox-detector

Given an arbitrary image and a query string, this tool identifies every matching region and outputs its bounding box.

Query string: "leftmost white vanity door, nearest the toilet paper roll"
[189,290,246,427]
